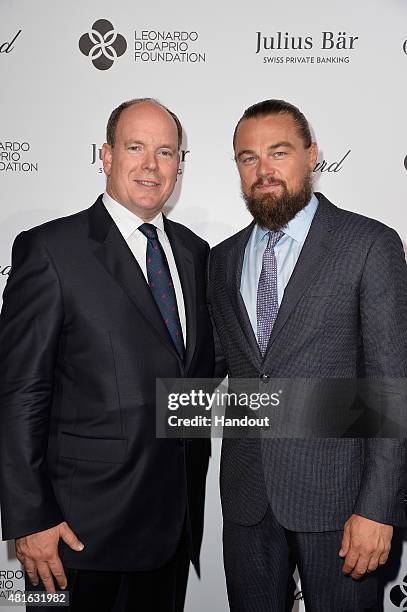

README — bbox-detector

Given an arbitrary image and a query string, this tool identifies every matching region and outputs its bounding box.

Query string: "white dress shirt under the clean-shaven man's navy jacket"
[103,192,187,345]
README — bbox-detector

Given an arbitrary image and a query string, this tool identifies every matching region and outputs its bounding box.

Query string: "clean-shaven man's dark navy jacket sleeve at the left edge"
[0,231,64,539]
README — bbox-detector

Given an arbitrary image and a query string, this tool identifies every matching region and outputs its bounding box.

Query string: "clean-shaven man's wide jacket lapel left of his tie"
[89,196,179,358]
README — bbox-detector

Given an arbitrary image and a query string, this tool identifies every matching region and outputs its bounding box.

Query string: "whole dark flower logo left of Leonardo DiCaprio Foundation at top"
[79,19,127,70]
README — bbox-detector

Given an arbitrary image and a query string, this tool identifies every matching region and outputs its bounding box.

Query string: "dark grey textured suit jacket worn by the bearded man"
[209,194,407,531]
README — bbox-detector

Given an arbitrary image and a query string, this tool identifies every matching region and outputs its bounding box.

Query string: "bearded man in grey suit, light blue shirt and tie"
[209,100,407,612]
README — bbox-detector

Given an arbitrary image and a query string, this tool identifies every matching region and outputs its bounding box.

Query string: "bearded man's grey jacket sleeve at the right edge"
[354,228,407,525]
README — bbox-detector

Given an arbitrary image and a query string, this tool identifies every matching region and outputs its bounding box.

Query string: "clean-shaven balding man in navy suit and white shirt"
[0,99,214,612]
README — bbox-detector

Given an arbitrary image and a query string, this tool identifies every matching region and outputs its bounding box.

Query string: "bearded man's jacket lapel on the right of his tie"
[265,194,336,359]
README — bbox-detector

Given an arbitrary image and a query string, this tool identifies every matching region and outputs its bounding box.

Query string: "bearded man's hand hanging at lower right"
[339,514,393,580]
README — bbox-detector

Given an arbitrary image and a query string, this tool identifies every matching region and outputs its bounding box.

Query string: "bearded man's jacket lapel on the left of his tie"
[226,221,262,367]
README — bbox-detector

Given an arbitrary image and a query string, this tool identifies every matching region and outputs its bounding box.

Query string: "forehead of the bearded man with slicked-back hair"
[235,113,303,152]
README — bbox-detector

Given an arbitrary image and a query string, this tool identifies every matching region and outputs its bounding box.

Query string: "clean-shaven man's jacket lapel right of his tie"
[164,217,197,371]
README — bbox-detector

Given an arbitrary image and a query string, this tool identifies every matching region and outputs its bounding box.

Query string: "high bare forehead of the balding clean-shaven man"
[116,102,178,145]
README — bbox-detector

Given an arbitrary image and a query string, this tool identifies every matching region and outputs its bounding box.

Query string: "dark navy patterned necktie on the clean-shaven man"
[138,223,185,359]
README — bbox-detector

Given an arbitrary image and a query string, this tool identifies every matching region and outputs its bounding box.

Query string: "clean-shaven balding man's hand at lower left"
[16,522,84,593]
